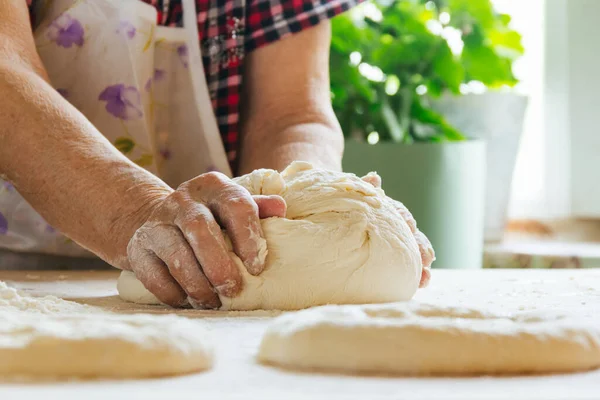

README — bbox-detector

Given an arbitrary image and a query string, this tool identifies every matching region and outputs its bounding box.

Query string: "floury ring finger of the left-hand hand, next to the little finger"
[151,225,221,309]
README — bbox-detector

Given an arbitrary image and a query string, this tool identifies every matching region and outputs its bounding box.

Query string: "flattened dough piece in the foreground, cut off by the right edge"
[258,303,600,375]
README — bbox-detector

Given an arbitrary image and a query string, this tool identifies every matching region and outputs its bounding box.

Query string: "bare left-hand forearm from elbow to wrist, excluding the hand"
[0,64,171,267]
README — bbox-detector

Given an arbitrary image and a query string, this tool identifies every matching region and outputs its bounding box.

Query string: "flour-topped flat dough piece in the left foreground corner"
[0,282,213,379]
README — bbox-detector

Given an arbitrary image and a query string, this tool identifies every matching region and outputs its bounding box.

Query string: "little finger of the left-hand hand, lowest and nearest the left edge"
[127,245,187,307]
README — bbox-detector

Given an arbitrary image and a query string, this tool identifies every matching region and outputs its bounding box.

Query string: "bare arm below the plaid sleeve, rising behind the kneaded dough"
[239,21,344,174]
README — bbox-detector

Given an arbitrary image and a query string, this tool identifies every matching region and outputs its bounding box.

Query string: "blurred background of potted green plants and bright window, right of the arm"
[331,0,600,268]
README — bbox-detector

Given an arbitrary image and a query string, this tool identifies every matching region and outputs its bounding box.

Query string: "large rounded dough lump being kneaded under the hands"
[117,162,422,310]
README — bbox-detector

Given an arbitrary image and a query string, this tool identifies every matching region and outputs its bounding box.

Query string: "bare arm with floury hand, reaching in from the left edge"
[0,0,285,308]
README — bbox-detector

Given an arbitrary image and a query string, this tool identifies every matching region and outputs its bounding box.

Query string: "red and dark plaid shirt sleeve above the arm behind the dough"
[245,0,363,52]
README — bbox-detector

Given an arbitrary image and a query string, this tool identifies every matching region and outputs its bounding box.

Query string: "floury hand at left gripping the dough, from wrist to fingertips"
[127,172,286,309]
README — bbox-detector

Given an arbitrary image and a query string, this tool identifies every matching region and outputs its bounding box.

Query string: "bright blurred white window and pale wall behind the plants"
[494,0,600,219]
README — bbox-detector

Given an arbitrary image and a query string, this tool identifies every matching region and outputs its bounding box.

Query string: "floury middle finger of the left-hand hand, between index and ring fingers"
[175,203,243,297]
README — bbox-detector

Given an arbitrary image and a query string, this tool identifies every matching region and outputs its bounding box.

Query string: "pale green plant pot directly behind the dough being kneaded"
[343,140,486,269]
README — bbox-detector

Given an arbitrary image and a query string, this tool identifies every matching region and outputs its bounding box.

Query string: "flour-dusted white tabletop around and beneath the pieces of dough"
[0,270,600,400]
